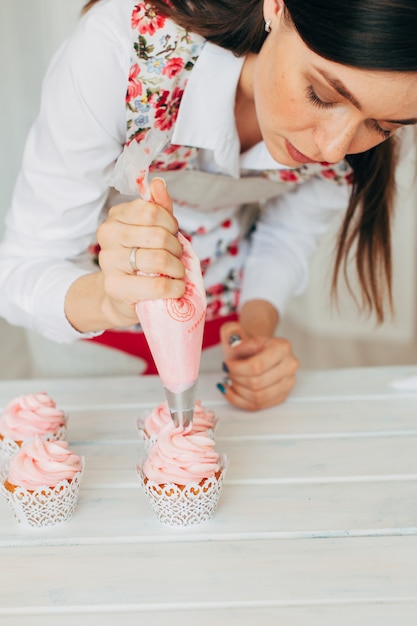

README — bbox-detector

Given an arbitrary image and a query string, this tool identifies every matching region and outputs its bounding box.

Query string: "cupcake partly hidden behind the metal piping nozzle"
[137,400,218,450]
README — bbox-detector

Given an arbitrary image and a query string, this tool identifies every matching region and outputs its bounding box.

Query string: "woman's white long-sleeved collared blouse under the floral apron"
[0,0,349,342]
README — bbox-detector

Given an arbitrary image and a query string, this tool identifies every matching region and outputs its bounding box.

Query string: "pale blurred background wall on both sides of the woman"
[0,0,417,378]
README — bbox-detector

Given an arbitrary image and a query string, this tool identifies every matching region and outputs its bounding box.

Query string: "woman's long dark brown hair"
[84,0,417,323]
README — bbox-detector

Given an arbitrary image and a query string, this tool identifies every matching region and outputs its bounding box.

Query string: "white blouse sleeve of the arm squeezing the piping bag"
[0,1,133,342]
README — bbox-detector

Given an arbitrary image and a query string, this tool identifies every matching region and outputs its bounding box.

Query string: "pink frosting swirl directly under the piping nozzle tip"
[143,421,220,485]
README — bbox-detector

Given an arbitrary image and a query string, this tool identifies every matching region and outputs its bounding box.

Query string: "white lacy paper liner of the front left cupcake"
[0,457,84,527]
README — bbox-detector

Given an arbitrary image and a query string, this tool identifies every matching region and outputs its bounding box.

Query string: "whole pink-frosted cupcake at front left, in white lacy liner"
[1,435,84,526]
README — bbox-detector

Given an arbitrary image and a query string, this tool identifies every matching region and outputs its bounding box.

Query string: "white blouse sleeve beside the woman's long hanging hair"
[240,179,351,316]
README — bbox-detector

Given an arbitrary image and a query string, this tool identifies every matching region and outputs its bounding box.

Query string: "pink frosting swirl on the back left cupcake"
[0,392,65,441]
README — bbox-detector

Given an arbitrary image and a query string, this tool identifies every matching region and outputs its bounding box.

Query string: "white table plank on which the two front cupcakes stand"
[0,481,417,549]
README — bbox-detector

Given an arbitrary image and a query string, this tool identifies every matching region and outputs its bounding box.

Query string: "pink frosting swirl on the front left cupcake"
[7,435,82,489]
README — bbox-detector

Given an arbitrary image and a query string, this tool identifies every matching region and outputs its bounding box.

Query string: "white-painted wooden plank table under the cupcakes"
[0,367,417,626]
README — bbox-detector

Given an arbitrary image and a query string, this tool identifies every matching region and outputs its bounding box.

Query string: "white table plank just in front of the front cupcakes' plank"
[0,536,417,615]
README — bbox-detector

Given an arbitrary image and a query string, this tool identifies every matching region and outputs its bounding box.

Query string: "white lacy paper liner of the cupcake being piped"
[136,455,228,526]
